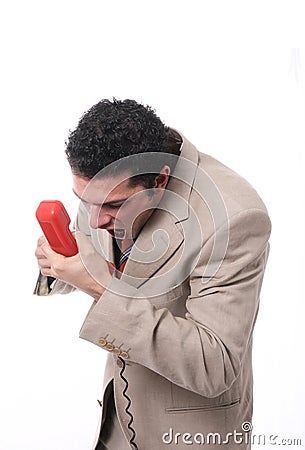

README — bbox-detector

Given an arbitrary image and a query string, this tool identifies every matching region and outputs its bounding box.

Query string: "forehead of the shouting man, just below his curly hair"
[72,173,135,204]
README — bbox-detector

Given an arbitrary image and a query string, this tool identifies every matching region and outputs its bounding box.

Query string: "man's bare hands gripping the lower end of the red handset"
[35,232,111,300]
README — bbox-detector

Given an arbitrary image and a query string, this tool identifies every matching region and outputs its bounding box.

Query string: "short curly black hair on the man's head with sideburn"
[66,98,181,188]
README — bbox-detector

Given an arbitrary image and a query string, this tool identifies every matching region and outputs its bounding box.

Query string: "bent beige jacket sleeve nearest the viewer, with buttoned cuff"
[80,209,271,397]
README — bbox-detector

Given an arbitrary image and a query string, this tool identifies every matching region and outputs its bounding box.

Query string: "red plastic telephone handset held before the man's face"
[36,200,78,256]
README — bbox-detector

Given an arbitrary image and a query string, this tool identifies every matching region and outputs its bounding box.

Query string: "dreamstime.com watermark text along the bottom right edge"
[162,422,302,448]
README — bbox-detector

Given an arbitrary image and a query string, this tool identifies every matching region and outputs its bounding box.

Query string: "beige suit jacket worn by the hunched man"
[35,133,271,450]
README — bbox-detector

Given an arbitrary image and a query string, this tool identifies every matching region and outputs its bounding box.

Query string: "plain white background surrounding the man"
[0,0,305,450]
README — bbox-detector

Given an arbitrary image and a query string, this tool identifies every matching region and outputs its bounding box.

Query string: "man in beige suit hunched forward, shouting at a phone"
[35,96,271,450]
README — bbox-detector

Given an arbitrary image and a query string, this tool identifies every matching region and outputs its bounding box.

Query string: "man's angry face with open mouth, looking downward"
[72,173,168,239]
